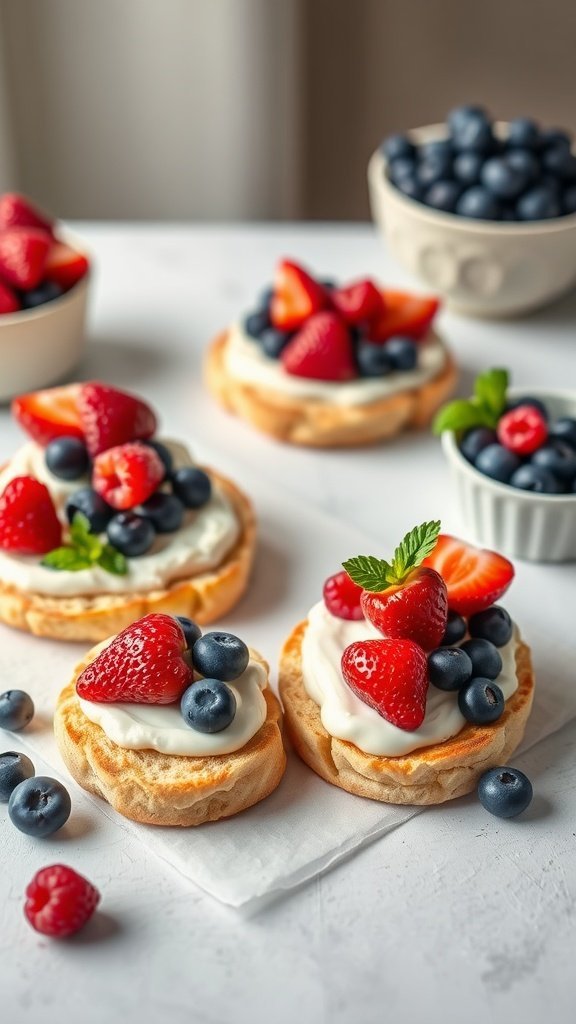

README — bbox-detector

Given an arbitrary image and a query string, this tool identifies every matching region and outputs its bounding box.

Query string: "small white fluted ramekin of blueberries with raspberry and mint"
[435,370,576,562]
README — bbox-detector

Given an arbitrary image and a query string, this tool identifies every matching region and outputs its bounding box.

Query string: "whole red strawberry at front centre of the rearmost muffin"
[280,312,358,381]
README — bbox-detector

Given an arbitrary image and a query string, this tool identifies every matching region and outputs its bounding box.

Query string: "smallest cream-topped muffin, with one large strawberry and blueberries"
[54,612,286,825]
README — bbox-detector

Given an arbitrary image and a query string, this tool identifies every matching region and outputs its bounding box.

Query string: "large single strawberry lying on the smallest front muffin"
[76,612,194,703]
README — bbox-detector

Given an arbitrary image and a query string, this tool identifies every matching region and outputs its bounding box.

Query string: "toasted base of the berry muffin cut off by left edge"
[0,469,256,642]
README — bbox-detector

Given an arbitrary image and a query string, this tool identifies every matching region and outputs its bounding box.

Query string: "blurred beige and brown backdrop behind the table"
[0,0,576,219]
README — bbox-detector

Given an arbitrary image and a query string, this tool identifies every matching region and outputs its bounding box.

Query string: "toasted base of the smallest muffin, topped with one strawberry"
[54,650,286,826]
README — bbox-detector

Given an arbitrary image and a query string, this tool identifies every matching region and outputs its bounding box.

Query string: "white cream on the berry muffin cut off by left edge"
[0,441,240,597]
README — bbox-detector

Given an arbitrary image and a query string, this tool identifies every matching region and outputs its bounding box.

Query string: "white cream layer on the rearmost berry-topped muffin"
[225,324,446,406]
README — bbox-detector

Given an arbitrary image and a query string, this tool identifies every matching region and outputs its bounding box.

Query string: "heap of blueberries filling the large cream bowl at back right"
[380,105,576,222]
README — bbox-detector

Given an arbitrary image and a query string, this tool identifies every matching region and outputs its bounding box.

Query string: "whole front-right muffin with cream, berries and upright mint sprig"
[280,522,534,804]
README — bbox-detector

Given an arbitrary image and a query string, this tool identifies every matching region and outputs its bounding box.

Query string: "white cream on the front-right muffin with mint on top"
[302,601,519,757]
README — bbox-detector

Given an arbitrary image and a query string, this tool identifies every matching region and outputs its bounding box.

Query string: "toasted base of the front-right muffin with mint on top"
[280,623,534,804]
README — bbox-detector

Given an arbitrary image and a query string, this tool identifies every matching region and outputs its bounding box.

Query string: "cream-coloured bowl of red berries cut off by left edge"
[0,193,90,401]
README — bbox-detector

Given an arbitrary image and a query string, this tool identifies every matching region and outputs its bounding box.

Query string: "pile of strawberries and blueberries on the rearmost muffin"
[239,260,439,382]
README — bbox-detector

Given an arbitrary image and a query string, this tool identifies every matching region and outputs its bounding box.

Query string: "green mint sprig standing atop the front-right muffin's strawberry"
[342,519,440,593]
